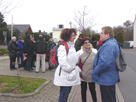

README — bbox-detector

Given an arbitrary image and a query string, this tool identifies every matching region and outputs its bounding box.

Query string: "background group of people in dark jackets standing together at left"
[8,34,55,73]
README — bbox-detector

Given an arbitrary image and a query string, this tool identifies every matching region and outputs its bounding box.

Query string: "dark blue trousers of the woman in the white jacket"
[58,86,72,102]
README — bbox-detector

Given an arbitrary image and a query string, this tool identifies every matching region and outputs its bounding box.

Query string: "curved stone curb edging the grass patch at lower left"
[0,77,50,98]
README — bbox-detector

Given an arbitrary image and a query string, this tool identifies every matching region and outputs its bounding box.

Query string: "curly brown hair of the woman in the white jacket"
[60,28,77,42]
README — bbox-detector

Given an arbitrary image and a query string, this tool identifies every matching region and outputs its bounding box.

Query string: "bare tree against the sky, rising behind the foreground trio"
[73,6,98,34]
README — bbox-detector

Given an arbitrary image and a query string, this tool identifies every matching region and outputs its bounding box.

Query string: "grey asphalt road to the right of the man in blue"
[118,49,136,102]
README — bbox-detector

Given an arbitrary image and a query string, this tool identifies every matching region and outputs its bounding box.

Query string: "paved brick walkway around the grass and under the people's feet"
[0,57,121,102]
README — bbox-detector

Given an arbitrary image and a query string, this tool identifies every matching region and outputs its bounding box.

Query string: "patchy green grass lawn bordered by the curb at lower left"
[0,76,47,94]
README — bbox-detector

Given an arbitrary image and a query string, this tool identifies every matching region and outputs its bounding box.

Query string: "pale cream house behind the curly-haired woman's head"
[52,25,81,42]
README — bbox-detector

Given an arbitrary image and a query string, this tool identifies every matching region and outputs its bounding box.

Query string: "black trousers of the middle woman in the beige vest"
[81,81,97,102]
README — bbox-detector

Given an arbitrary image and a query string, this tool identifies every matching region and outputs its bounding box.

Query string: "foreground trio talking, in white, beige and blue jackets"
[53,26,119,102]
